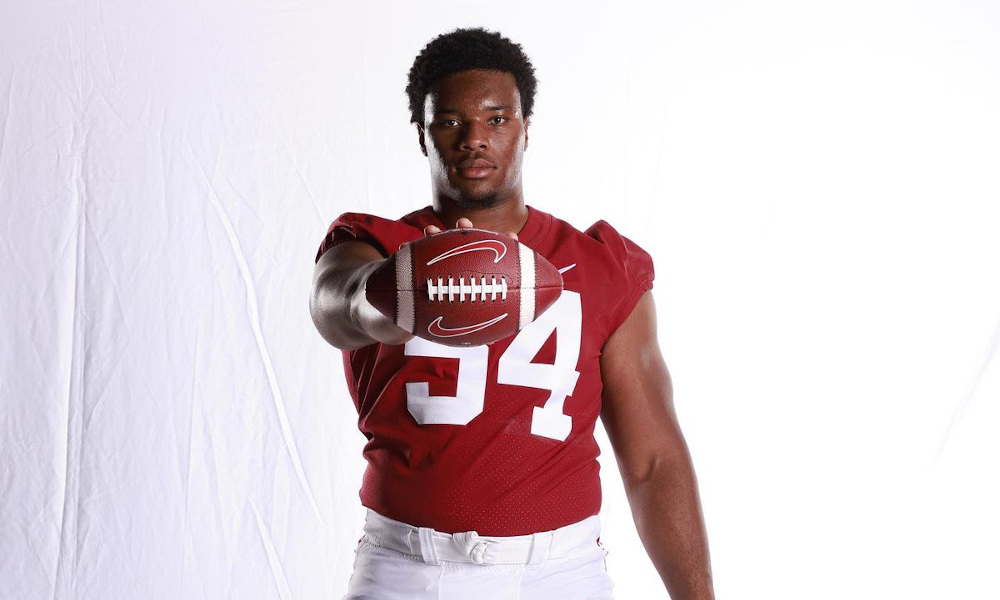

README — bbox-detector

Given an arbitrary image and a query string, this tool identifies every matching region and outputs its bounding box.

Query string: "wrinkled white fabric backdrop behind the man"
[0,0,1000,600]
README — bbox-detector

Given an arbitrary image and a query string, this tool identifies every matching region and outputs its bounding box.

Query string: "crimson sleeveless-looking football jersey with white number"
[316,207,653,536]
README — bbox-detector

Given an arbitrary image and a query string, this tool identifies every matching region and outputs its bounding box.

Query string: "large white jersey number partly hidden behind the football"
[403,290,583,441]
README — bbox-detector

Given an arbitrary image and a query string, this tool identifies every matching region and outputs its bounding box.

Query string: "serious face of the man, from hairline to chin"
[418,70,528,208]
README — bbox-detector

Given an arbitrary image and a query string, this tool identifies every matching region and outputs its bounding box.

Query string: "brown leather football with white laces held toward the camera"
[365,228,563,346]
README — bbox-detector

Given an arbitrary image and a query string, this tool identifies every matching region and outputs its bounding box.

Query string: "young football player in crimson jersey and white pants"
[310,29,713,600]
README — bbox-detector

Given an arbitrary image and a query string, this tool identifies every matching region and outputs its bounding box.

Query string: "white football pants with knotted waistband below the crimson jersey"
[344,509,614,600]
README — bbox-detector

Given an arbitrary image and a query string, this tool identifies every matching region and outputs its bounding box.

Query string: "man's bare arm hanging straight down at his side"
[601,292,715,600]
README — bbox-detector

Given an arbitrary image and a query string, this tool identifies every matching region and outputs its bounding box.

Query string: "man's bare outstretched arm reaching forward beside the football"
[309,241,413,350]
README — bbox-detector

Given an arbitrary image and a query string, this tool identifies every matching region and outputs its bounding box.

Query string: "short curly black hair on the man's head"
[406,27,538,124]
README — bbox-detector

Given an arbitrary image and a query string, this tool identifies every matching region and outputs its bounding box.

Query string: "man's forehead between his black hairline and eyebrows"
[424,69,521,114]
